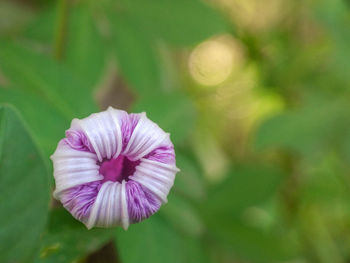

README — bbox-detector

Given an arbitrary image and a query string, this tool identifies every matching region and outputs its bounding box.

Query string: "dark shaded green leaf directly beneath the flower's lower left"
[37,208,114,263]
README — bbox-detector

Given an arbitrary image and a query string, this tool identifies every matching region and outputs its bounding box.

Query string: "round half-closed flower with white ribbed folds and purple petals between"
[51,107,179,229]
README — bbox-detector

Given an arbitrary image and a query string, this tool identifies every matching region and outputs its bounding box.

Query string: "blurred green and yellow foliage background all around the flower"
[0,0,350,263]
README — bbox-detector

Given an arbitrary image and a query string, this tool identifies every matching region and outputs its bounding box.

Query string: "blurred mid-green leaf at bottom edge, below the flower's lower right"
[116,215,206,263]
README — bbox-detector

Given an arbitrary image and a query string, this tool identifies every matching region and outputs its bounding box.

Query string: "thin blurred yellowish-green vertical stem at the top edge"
[53,0,68,60]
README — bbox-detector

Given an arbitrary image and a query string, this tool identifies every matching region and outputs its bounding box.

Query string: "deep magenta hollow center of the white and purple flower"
[99,155,140,182]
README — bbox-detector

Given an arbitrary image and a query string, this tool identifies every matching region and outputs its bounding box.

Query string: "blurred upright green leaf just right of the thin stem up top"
[64,5,104,89]
